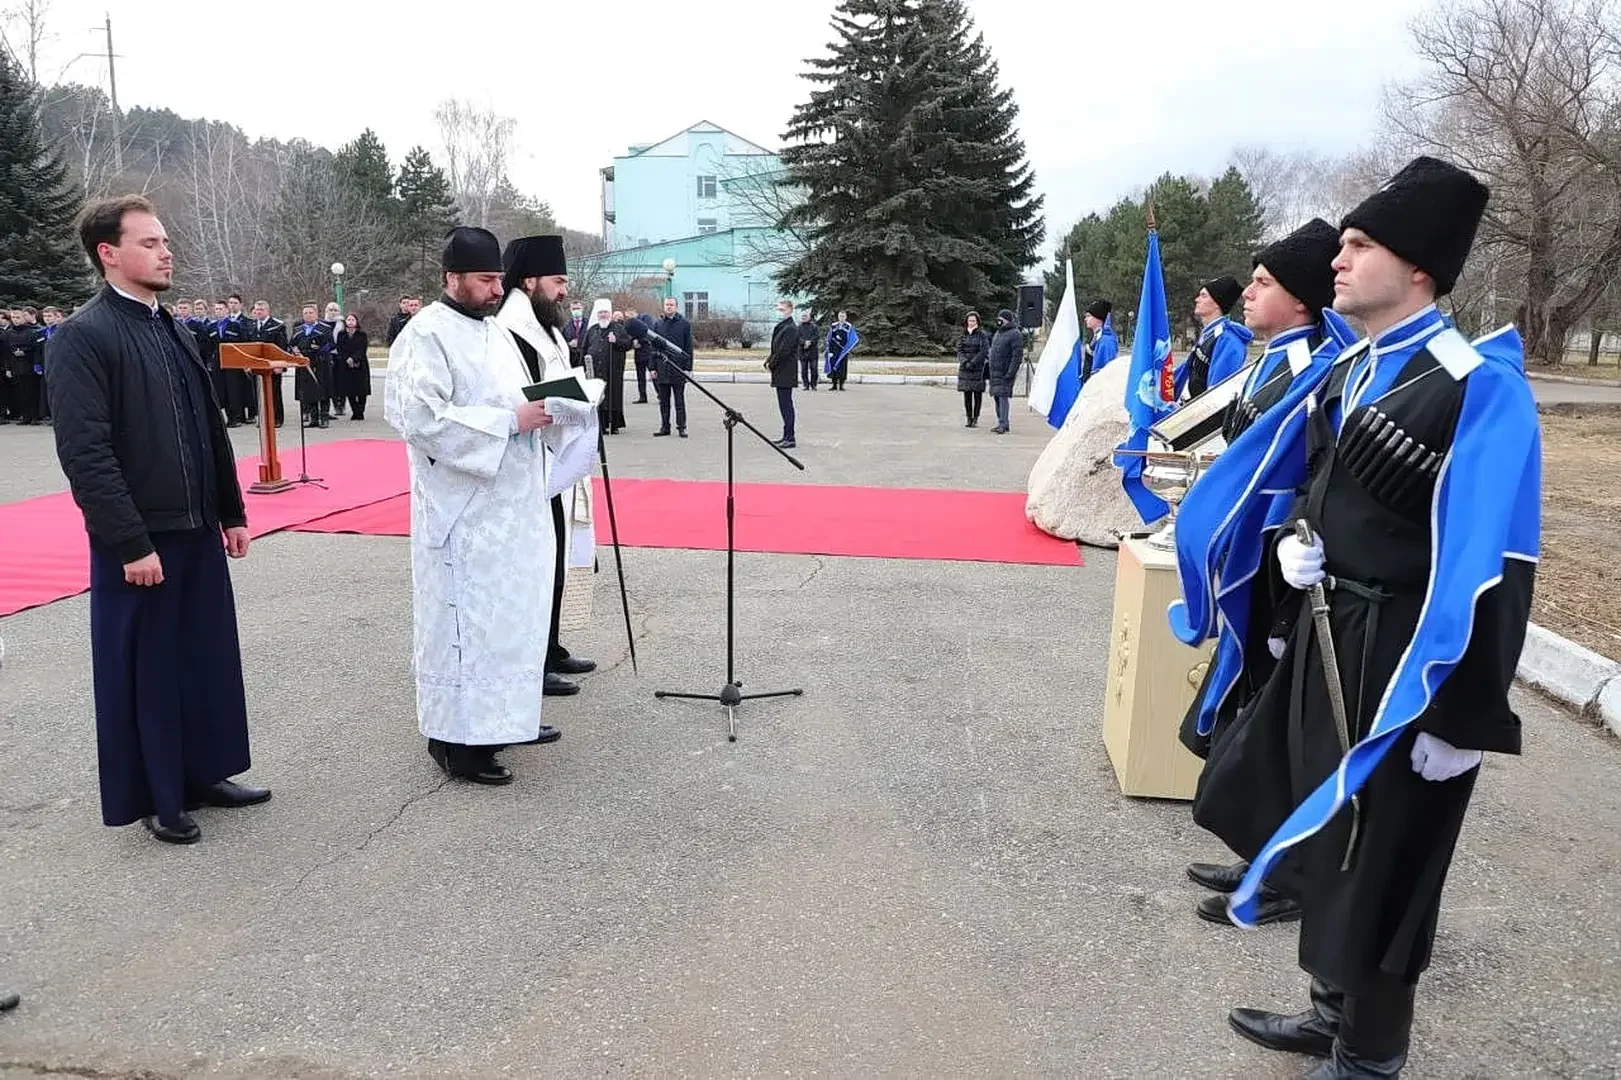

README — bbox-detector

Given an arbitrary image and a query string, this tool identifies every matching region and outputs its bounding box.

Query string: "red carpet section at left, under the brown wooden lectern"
[0,431,410,616]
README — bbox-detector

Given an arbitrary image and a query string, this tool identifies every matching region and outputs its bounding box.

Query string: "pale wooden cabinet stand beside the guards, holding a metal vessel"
[1104,540,1211,799]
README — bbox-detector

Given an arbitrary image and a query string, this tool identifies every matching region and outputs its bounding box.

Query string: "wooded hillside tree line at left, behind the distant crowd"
[0,43,601,327]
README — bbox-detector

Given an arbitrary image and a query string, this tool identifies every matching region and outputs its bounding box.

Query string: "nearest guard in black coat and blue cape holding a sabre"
[1193,157,1542,1080]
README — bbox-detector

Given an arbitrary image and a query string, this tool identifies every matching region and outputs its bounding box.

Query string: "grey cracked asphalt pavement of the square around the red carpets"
[0,386,1621,1080]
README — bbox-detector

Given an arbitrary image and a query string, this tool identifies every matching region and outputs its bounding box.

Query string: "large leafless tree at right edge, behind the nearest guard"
[1386,0,1621,363]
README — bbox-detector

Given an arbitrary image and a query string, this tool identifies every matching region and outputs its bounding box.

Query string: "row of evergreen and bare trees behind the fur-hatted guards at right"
[1047,0,1621,363]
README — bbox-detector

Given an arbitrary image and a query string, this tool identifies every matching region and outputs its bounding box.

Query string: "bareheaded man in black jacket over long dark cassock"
[49,195,271,843]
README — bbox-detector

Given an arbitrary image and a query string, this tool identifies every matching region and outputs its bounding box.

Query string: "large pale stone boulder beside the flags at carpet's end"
[1024,355,1144,548]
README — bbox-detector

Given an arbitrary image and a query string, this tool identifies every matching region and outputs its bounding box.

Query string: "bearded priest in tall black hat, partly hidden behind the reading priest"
[496,237,606,696]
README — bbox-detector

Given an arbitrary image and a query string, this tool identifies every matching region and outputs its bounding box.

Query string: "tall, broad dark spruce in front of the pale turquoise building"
[778,0,1044,355]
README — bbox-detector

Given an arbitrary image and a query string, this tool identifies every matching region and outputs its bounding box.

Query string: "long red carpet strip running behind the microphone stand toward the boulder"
[295,478,1081,566]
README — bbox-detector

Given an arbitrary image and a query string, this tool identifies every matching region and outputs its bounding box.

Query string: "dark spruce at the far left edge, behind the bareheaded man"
[0,49,91,306]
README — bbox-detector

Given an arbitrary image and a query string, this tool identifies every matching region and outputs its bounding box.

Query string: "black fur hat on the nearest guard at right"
[1339,157,1491,297]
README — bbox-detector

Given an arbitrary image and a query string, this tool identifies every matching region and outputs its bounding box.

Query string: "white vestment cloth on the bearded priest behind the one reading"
[496,290,611,568]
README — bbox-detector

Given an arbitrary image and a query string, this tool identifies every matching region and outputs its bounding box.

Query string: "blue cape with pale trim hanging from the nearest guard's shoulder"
[1227,326,1542,926]
